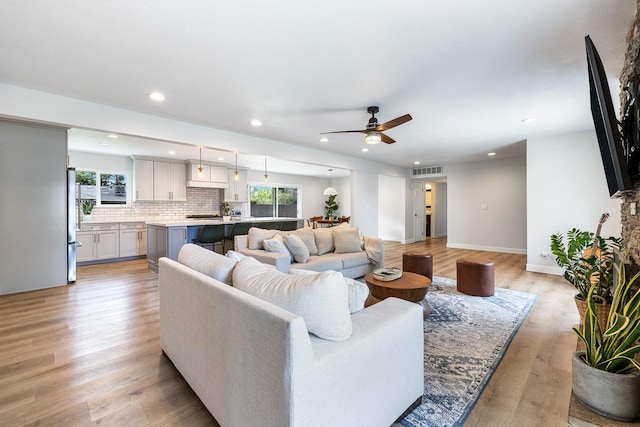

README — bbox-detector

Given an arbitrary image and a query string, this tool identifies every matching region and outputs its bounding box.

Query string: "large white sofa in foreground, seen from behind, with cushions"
[158,245,423,427]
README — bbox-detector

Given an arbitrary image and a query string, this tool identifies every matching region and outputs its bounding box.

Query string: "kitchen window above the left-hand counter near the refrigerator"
[76,170,127,206]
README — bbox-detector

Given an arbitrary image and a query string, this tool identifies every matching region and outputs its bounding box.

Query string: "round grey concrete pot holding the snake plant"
[571,352,640,421]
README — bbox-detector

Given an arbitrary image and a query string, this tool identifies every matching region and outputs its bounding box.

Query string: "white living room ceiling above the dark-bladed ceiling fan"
[0,0,635,173]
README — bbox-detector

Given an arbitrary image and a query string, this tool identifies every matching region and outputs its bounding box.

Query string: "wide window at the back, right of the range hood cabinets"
[249,185,301,218]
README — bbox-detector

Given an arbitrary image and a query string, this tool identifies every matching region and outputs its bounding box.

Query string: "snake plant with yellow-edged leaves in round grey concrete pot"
[572,263,640,421]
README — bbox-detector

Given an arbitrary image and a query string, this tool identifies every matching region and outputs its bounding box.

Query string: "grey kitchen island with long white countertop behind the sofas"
[146,217,304,272]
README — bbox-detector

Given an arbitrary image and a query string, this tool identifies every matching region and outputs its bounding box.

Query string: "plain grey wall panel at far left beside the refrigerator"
[0,121,67,294]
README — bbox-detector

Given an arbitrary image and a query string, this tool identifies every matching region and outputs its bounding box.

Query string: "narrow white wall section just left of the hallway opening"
[377,176,404,242]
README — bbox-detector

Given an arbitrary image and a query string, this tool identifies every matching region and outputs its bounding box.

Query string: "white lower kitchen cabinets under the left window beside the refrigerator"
[76,224,120,262]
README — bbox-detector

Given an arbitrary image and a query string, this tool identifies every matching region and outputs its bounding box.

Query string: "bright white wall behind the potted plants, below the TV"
[527,131,622,274]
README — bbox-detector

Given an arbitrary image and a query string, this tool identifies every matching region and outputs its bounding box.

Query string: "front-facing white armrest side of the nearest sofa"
[293,298,424,426]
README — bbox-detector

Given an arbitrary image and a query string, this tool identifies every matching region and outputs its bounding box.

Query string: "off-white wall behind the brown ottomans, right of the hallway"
[446,157,527,254]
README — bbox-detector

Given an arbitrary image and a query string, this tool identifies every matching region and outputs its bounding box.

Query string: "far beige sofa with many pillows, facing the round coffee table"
[234,224,384,278]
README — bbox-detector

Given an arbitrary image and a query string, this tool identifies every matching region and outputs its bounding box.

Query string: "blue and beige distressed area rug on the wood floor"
[394,277,537,427]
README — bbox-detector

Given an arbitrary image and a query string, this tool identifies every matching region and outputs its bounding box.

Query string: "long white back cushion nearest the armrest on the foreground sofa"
[233,257,353,341]
